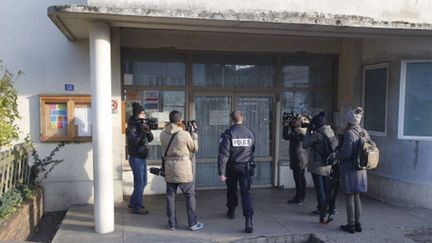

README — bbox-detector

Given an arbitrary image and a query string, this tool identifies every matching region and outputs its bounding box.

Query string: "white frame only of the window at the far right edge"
[398,59,432,141]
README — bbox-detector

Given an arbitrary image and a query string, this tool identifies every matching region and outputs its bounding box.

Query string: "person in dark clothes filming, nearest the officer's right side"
[282,114,309,205]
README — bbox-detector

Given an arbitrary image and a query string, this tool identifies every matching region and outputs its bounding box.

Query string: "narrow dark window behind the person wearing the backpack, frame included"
[362,64,388,136]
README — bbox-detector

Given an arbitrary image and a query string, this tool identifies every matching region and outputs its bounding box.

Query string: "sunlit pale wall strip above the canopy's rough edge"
[88,0,432,23]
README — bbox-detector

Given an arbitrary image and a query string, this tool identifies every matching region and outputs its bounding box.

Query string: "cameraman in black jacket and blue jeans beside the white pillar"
[126,103,153,214]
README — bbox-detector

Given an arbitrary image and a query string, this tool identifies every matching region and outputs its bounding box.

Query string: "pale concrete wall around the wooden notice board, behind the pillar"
[0,0,123,211]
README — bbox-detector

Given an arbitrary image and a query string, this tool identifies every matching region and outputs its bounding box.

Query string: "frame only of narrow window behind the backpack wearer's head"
[362,63,389,137]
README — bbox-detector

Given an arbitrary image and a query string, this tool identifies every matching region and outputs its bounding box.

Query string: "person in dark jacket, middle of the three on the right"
[303,112,338,222]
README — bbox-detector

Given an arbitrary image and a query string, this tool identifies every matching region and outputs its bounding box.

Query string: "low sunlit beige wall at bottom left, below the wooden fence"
[0,189,44,240]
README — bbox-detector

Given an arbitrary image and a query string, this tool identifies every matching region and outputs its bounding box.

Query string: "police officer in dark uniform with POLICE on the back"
[218,111,255,233]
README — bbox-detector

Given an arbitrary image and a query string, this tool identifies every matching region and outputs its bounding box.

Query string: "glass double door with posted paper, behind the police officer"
[194,93,273,188]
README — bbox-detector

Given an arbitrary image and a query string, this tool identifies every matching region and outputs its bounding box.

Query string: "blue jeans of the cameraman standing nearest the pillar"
[129,157,147,209]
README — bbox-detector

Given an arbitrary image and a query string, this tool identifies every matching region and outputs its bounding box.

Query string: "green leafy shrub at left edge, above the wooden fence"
[0,60,23,148]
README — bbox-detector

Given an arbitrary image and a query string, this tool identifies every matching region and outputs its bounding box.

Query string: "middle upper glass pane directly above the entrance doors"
[192,55,276,87]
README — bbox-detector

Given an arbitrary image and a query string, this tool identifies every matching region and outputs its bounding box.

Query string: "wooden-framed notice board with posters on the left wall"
[39,95,91,142]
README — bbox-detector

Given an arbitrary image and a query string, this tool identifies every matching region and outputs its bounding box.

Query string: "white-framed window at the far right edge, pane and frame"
[398,60,432,141]
